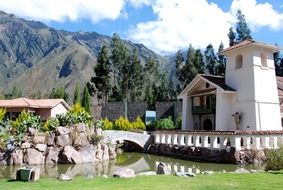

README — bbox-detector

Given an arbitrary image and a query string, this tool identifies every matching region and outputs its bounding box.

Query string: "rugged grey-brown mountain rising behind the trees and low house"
[0,11,168,102]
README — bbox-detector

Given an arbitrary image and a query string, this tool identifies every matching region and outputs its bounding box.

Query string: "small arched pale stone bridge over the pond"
[103,130,153,150]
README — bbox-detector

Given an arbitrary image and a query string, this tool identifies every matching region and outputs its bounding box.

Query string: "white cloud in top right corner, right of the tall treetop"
[231,0,283,30]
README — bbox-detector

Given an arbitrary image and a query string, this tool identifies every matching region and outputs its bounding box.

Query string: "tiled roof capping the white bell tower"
[220,40,280,54]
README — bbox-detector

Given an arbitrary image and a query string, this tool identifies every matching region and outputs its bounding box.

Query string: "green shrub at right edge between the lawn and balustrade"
[265,145,283,171]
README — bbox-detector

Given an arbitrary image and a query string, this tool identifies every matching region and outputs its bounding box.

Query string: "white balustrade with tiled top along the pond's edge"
[154,131,283,150]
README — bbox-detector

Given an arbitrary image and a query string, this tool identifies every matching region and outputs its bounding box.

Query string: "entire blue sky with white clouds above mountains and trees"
[0,0,283,54]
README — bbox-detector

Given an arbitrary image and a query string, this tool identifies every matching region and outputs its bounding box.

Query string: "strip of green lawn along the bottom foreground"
[0,171,283,190]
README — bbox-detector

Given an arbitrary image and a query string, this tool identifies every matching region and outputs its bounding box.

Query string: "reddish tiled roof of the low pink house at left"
[0,98,70,110]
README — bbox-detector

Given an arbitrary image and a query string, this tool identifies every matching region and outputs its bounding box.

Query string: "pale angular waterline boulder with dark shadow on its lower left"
[60,146,82,164]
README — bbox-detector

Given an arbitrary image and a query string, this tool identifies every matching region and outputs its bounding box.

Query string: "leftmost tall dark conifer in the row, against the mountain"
[87,46,112,103]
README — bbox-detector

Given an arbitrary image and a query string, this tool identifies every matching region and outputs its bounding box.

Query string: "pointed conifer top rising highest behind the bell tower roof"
[236,9,252,43]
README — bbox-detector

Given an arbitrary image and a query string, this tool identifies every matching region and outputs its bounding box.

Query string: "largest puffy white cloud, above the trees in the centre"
[128,0,234,53]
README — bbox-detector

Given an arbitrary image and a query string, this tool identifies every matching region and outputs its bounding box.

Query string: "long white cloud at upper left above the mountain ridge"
[0,0,125,22]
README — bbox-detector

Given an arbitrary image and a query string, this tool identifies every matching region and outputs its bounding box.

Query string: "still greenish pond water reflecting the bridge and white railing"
[0,152,262,178]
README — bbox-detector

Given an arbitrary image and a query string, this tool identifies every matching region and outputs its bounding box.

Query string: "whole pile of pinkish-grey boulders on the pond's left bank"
[0,124,116,165]
